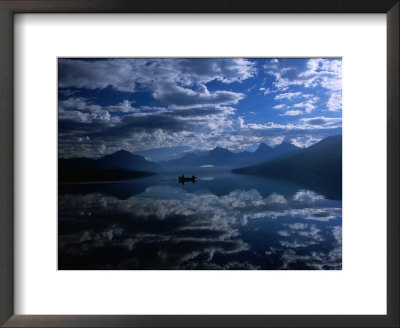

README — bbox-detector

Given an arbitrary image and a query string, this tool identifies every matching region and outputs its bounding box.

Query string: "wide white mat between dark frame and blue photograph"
[15,14,386,314]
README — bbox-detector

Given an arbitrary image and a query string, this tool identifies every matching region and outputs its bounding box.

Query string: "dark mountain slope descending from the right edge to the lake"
[232,135,342,199]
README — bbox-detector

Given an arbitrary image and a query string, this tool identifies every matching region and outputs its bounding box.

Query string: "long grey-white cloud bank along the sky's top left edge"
[59,58,257,92]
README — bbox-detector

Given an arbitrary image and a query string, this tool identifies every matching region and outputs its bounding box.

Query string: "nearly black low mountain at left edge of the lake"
[58,150,161,181]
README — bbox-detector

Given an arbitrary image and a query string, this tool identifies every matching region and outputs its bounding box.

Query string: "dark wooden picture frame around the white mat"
[0,0,400,327]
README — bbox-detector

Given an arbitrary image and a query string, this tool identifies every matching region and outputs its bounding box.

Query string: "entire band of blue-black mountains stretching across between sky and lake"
[58,135,342,199]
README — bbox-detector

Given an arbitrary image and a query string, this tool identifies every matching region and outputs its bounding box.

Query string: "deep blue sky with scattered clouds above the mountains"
[58,58,342,158]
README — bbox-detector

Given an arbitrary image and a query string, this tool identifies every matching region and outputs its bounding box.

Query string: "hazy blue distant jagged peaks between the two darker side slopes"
[159,142,300,169]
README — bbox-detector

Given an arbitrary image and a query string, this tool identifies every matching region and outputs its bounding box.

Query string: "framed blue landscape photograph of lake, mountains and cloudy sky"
[56,57,347,270]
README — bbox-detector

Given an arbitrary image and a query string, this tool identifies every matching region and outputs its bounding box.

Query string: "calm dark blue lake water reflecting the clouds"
[58,172,342,270]
